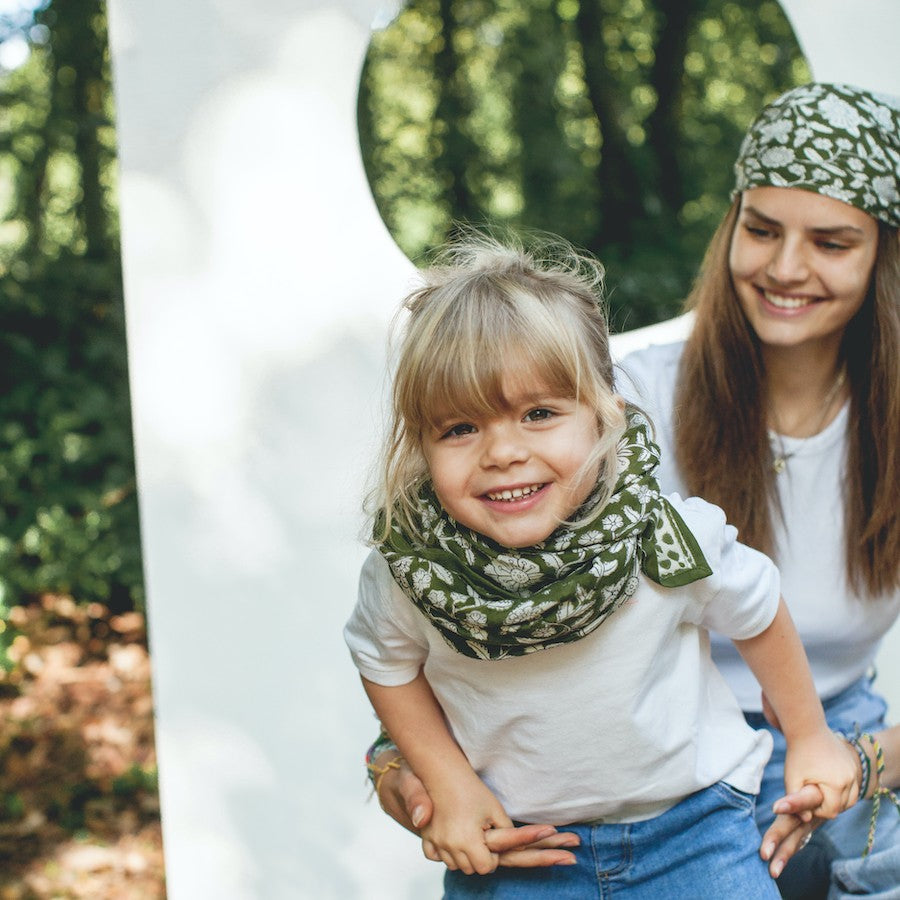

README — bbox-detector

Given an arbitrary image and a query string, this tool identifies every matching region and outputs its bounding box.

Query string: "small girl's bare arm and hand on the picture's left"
[362,671,512,875]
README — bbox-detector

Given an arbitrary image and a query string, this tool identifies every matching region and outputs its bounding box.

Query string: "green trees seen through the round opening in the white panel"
[359,0,810,328]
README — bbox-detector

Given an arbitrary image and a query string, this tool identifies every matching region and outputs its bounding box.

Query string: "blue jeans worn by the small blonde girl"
[444,782,778,900]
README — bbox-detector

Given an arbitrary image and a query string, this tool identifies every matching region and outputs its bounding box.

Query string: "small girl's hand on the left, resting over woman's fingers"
[421,772,512,875]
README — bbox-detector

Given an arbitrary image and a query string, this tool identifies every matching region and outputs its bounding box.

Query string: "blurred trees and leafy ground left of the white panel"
[0,0,165,888]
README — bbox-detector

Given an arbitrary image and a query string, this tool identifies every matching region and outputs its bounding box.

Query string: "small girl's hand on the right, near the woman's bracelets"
[776,729,860,819]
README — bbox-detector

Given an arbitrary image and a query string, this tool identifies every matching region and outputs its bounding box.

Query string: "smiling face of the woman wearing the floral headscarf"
[729,187,878,352]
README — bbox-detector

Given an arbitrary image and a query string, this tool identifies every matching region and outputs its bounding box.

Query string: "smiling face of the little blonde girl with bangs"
[422,372,600,547]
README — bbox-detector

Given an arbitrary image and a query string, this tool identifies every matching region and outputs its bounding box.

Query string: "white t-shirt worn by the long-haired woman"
[617,342,900,712]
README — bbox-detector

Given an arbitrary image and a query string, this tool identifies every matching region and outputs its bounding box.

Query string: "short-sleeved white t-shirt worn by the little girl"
[344,497,779,824]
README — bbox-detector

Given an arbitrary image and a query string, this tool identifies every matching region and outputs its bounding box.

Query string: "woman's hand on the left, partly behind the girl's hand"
[375,750,580,868]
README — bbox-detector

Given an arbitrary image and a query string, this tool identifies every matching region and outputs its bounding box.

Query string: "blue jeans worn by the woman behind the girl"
[746,677,900,900]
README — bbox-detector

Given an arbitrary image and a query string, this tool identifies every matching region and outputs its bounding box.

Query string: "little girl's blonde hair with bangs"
[367,232,625,542]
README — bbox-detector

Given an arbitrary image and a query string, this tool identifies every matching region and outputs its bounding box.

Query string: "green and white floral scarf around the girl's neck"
[379,408,712,659]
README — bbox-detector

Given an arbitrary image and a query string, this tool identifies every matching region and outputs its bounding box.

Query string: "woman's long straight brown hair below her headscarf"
[674,198,900,596]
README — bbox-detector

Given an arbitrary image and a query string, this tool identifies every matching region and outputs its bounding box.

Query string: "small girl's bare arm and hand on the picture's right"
[734,600,859,819]
